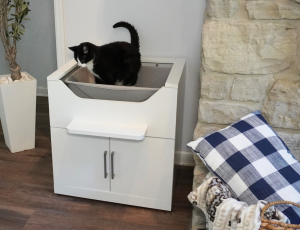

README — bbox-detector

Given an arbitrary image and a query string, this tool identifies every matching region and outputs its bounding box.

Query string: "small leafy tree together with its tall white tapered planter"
[0,0,36,153]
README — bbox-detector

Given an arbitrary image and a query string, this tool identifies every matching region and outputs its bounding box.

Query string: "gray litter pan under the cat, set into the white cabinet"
[63,63,173,102]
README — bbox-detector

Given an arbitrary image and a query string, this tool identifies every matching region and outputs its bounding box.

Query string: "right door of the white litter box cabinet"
[110,137,174,201]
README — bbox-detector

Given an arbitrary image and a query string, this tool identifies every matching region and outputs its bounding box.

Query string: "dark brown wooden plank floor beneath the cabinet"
[0,97,193,230]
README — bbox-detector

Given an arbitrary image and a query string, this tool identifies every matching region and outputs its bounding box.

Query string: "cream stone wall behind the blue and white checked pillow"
[193,0,300,230]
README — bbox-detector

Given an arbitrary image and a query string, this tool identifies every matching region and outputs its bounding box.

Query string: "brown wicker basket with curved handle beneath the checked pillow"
[259,201,300,230]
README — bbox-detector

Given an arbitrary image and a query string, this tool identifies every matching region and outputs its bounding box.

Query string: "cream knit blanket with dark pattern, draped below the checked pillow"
[188,173,289,230]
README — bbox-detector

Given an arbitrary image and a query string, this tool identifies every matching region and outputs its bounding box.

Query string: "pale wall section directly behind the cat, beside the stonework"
[65,0,206,162]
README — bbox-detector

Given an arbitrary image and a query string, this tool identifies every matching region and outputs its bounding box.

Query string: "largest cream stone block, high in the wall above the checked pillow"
[202,21,297,74]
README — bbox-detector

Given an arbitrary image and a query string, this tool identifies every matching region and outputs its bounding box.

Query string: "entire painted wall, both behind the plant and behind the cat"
[0,0,206,162]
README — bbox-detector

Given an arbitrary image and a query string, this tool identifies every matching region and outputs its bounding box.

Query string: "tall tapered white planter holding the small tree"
[0,74,36,153]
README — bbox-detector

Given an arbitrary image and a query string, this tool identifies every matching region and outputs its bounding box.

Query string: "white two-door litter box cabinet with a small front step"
[48,58,185,211]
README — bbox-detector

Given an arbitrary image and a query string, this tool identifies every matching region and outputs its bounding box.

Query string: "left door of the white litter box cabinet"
[51,128,110,191]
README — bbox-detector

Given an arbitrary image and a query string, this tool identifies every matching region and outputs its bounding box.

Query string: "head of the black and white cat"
[69,42,95,67]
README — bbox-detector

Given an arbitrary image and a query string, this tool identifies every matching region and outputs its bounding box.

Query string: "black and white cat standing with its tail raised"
[69,22,141,86]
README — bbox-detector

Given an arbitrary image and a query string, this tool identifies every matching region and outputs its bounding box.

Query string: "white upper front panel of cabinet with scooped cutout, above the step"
[48,81,177,139]
